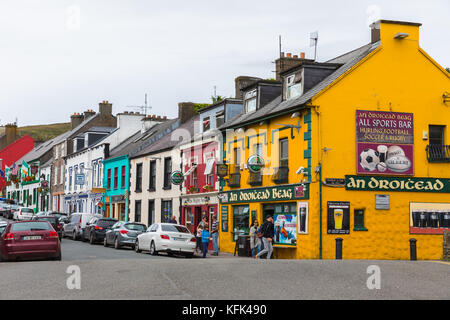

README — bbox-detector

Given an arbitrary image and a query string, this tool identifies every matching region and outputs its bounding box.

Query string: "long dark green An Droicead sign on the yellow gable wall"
[345,175,450,193]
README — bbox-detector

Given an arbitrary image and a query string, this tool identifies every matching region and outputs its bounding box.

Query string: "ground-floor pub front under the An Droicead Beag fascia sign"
[219,184,309,258]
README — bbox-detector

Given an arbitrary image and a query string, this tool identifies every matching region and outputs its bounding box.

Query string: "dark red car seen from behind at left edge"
[0,221,61,260]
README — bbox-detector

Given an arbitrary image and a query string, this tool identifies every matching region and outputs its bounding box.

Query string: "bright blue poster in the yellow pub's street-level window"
[273,213,297,246]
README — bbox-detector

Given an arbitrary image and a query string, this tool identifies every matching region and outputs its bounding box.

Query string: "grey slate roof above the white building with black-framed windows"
[130,115,200,158]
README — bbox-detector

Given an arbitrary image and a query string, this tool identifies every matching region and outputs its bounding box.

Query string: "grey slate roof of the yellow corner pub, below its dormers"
[218,42,380,130]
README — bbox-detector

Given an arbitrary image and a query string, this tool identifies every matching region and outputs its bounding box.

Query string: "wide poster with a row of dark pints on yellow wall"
[409,202,450,234]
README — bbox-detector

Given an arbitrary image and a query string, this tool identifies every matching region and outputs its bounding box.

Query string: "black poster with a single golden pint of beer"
[327,201,350,234]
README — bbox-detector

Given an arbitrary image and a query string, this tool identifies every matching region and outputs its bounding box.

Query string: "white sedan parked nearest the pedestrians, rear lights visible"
[134,223,196,257]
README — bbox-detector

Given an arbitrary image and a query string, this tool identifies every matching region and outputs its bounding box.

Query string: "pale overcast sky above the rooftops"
[0,0,450,126]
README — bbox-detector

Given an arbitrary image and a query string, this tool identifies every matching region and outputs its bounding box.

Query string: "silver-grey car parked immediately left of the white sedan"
[103,221,147,249]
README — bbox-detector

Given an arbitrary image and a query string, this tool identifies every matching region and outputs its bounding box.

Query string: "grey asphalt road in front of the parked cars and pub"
[0,218,450,300]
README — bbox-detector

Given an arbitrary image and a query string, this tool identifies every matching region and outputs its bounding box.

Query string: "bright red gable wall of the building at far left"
[0,135,34,196]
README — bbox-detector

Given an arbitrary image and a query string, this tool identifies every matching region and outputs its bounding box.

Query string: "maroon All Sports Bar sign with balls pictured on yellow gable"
[356,110,414,175]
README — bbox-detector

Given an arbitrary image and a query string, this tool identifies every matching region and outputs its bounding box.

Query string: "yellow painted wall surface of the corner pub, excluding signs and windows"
[219,23,450,259]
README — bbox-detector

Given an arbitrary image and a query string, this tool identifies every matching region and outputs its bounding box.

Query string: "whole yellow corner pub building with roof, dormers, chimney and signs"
[219,20,450,259]
